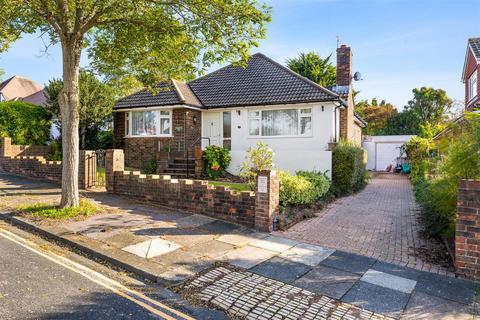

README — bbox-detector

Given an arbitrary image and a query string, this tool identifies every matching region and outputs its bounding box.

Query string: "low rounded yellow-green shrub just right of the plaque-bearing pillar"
[278,171,330,206]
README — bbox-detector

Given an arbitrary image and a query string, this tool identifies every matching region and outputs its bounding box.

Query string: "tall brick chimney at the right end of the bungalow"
[337,44,355,142]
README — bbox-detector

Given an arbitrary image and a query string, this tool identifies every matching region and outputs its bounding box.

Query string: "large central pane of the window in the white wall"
[262,109,298,136]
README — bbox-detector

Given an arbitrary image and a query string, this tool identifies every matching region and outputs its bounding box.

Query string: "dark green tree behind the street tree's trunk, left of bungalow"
[45,70,115,149]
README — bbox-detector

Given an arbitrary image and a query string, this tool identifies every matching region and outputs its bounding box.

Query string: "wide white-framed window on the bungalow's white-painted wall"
[248,108,312,137]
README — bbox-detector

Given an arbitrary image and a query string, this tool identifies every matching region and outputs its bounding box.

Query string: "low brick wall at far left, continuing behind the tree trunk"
[0,137,95,189]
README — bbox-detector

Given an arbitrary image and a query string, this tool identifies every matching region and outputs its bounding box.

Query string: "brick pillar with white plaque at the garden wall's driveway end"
[255,171,280,232]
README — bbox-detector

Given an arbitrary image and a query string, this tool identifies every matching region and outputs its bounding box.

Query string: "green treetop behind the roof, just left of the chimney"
[287,51,337,87]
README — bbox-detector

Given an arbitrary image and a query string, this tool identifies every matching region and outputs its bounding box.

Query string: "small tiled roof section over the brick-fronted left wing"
[114,80,200,109]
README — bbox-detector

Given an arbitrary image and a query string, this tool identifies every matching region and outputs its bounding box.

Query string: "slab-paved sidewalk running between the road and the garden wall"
[0,174,478,319]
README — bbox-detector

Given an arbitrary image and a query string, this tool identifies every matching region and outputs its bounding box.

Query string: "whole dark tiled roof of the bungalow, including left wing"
[115,53,340,109]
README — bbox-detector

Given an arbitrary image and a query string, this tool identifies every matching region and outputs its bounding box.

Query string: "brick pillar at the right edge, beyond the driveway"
[455,180,480,280]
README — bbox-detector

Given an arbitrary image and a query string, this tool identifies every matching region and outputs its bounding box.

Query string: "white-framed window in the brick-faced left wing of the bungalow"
[125,110,172,137]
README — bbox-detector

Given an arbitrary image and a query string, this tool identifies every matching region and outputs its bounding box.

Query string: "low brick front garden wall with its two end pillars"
[106,149,279,231]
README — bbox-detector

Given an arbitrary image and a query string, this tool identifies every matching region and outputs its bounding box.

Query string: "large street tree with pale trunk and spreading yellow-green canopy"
[0,0,271,207]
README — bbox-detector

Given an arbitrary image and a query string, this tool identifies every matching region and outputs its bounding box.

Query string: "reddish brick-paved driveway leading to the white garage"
[277,173,452,275]
